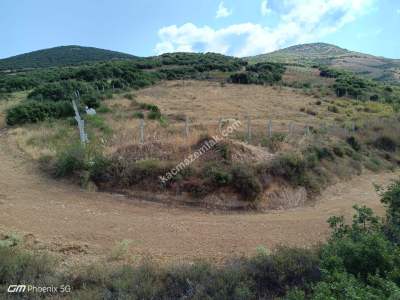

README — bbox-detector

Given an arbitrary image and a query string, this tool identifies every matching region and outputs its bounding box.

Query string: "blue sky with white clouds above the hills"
[0,0,400,58]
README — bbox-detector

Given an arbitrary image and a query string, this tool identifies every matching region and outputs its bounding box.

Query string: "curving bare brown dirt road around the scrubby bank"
[0,133,396,260]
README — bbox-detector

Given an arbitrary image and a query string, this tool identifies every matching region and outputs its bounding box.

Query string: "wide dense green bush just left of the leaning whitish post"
[6,101,74,126]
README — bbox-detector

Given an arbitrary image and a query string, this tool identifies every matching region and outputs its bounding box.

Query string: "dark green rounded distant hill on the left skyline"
[0,46,135,70]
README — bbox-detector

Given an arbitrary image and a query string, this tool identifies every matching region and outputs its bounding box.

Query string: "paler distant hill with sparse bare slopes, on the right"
[247,43,400,83]
